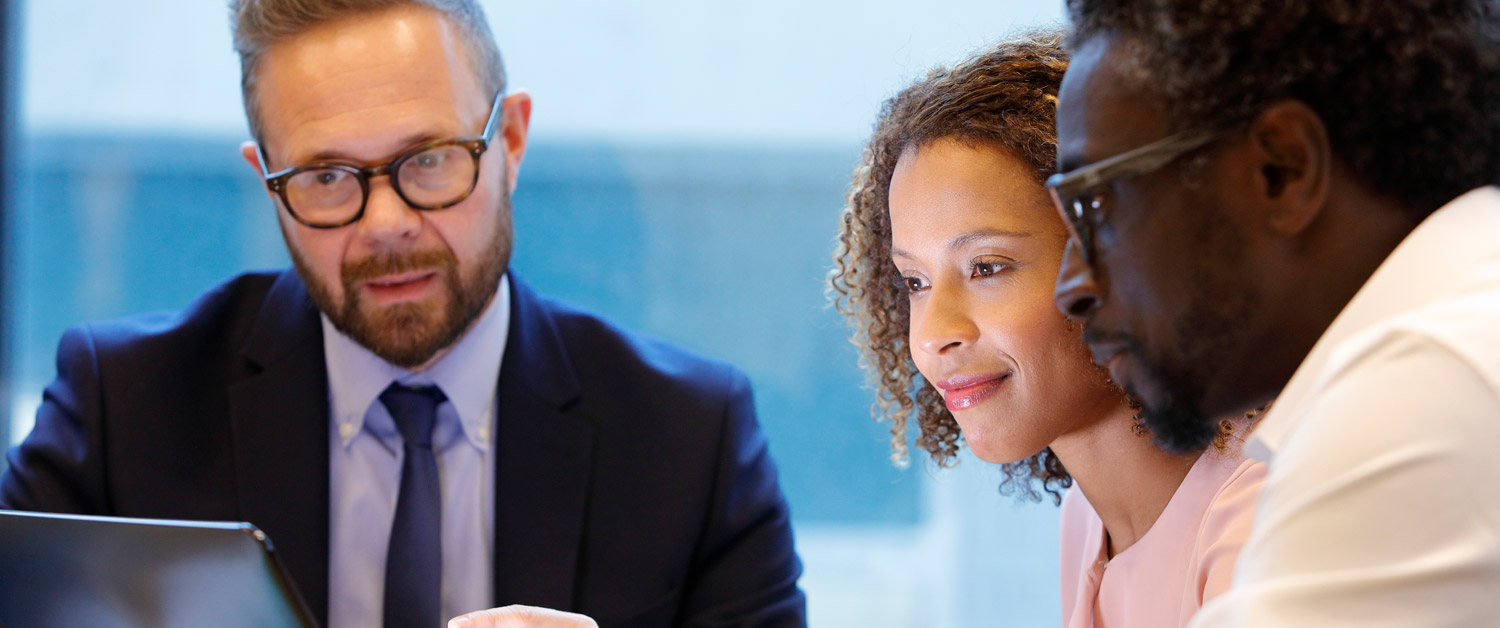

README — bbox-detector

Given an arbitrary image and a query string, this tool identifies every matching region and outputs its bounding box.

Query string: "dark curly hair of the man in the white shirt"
[1068,0,1500,219]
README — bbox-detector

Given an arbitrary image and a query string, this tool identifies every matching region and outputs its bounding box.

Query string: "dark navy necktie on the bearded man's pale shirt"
[380,384,447,628]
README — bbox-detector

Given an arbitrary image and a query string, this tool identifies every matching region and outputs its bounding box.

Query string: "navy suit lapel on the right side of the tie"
[495,274,594,609]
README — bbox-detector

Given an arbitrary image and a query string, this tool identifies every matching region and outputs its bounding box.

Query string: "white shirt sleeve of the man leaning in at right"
[1191,333,1500,628]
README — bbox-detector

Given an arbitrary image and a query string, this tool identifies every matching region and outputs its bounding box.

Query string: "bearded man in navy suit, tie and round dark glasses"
[0,0,806,628]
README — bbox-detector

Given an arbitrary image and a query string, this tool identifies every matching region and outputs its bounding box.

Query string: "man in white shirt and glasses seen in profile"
[1049,0,1500,628]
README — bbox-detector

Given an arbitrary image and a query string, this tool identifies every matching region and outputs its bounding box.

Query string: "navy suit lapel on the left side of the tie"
[230,271,329,624]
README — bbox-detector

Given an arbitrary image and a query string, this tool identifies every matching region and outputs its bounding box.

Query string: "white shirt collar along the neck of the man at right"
[1245,186,1500,462]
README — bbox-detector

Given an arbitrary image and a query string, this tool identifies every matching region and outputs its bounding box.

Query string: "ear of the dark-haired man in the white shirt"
[1248,100,1334,235]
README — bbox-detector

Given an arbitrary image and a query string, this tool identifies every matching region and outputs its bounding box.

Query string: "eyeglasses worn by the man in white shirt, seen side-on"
[1047,124,1241,267]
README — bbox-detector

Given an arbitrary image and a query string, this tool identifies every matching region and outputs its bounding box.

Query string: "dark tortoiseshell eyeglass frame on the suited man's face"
[255,91,506,229]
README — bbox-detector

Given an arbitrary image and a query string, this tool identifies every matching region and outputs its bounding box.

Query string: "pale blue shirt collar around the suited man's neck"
[320,274,510,451]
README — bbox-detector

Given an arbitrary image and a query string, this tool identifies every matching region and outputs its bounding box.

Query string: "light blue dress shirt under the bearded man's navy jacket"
[323,277,510,628]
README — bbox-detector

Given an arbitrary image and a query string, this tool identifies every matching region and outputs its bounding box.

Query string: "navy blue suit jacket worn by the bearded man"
[0,271,806,628]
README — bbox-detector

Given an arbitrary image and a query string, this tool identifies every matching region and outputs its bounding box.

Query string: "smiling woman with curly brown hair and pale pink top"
[830,31,1265,628]
